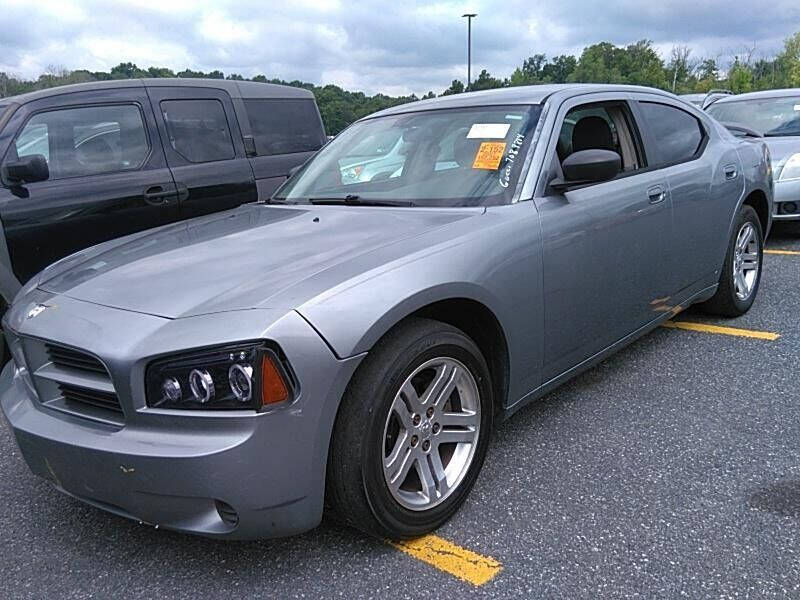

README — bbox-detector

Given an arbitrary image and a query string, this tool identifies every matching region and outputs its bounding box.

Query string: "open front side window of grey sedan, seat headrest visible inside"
[556,102,644,172]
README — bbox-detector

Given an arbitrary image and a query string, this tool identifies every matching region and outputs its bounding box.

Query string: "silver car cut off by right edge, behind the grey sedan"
[708,88,800,221]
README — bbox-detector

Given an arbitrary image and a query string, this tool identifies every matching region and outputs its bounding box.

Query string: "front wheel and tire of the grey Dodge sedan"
[326,318,493,539]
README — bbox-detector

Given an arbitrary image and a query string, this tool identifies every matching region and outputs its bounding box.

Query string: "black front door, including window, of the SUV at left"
[0,87,178,282]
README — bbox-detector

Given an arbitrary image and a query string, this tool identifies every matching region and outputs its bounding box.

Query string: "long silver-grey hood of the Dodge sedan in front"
[38,204,483,319]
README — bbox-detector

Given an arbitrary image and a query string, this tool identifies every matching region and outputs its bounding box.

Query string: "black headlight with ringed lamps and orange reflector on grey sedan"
[146,342,295,410]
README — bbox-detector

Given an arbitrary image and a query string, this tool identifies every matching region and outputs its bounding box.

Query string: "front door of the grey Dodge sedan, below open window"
[535,94,672,382]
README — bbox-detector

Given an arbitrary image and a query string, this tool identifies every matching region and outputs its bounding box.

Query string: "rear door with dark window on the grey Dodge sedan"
[634,94,744,295]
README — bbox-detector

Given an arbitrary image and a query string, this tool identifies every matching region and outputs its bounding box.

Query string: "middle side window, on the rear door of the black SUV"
[161,100,235,163]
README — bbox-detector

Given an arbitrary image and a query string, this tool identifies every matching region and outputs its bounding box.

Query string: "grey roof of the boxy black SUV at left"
[2,77,314,104]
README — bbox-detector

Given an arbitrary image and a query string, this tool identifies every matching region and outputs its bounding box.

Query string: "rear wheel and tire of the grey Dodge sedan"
[700,205,764,317]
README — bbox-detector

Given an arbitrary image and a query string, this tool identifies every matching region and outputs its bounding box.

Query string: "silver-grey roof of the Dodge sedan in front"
[365,83,676,119]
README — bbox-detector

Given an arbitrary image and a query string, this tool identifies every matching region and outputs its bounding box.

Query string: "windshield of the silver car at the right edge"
[708,97,800,136]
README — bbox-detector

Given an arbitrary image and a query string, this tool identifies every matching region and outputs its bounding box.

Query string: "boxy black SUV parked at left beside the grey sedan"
[0,79,327,303]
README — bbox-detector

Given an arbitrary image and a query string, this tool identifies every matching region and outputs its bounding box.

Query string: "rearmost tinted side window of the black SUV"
[244,99,325,156]
